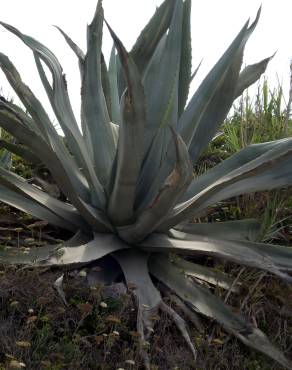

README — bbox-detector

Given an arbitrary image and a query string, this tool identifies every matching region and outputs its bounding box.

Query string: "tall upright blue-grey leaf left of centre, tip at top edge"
[81,1,116,187]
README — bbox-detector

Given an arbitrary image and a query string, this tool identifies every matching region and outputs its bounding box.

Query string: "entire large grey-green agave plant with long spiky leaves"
[0,0,292,368]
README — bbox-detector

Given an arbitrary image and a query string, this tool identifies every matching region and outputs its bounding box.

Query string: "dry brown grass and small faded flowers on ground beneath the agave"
[0,265,292,370]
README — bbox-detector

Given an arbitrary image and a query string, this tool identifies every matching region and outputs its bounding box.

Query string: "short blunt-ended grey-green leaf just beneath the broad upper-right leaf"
[170,219,261,241]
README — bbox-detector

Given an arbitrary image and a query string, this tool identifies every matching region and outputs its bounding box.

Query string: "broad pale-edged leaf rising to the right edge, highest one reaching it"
[162,139,292,229]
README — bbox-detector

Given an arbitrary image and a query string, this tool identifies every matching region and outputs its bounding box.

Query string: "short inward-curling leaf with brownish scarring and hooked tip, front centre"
[118,132,192,243]
